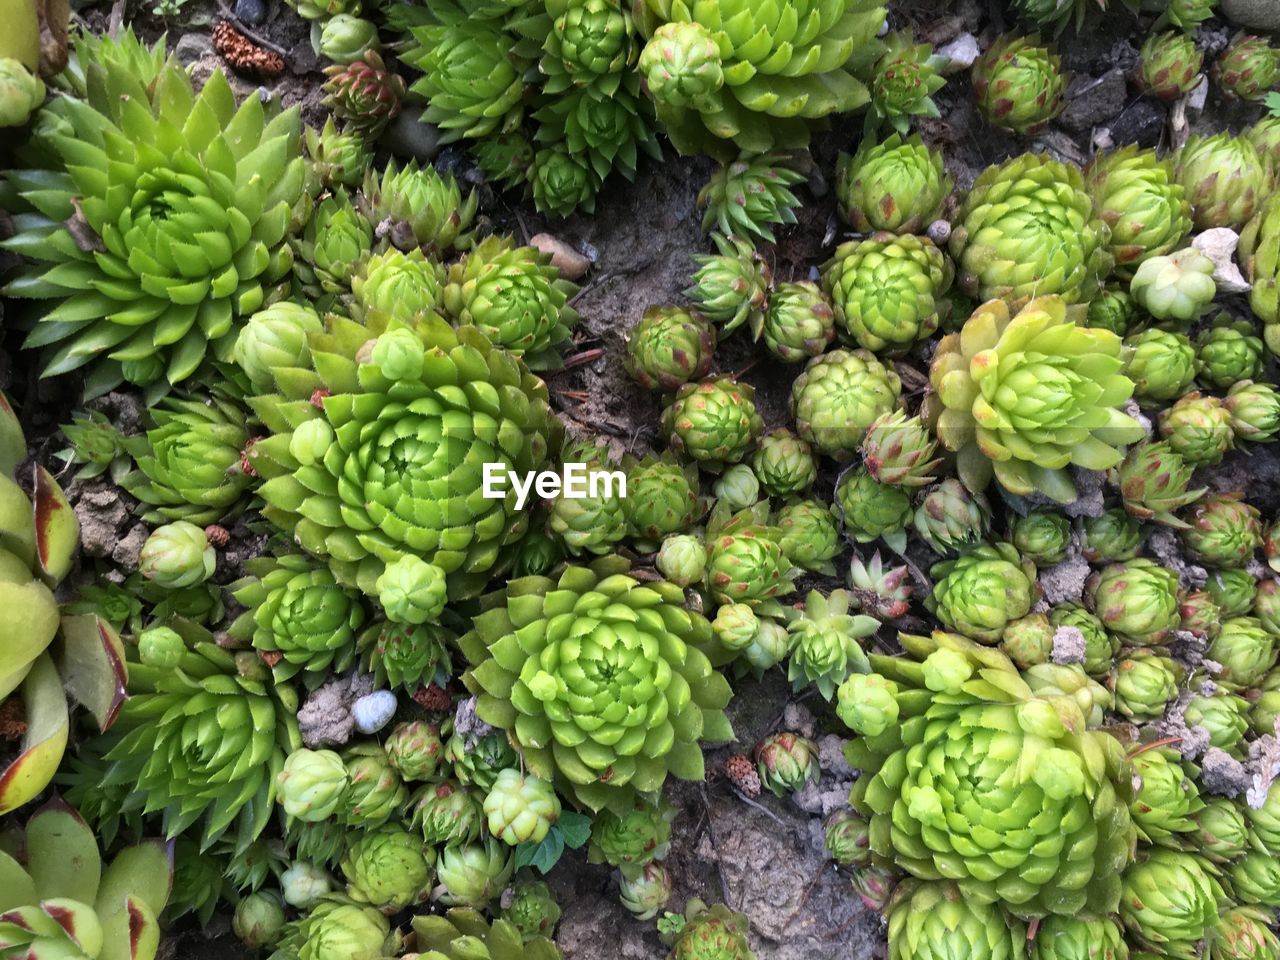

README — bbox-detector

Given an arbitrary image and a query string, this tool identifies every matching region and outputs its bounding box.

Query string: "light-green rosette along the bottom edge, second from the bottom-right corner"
[1120,847,1225,960]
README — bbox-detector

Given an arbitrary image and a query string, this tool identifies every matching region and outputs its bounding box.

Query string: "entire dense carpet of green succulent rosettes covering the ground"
[0,0,1280,960]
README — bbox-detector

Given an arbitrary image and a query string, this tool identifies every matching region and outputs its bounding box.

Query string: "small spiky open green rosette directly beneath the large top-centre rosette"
[698,154,804,243]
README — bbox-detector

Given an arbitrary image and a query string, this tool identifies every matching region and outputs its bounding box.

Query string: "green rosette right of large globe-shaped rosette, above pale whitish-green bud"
[1084,145,1192,277]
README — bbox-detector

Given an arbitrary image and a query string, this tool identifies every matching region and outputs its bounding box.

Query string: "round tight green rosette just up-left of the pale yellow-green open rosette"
[822,233,952,355]
